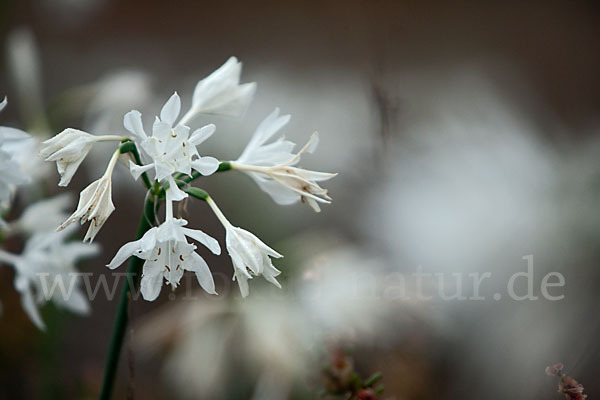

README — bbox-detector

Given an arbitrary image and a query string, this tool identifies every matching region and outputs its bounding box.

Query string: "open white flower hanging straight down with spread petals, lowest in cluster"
[107,200,221,301]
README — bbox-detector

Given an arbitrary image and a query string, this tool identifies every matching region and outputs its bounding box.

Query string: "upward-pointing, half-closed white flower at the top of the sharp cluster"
[181,57,256,124]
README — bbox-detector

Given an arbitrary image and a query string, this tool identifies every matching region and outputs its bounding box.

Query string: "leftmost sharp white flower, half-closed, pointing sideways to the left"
[40,128,122,186]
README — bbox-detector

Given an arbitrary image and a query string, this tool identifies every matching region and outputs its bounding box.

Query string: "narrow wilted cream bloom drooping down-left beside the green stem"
[57,150,121,242]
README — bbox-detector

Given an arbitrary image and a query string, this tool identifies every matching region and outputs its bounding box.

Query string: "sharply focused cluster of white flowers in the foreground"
[40,57,336,301]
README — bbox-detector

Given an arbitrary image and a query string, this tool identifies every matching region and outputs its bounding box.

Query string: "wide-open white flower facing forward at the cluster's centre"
[123,92,219,195]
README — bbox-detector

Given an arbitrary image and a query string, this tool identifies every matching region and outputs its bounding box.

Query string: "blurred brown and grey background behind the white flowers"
[0,0,600,400]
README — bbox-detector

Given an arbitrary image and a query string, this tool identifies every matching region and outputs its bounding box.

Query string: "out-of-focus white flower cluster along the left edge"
[0,99,99,329]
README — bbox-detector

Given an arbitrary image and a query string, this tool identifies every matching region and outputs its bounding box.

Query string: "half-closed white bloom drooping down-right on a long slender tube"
[206,197,283,297]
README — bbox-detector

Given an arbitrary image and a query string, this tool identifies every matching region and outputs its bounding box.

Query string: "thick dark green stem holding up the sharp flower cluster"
[99,197,154,400]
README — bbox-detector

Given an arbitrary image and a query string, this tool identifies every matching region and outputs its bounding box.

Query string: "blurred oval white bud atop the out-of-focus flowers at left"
[10,193,71,235]
